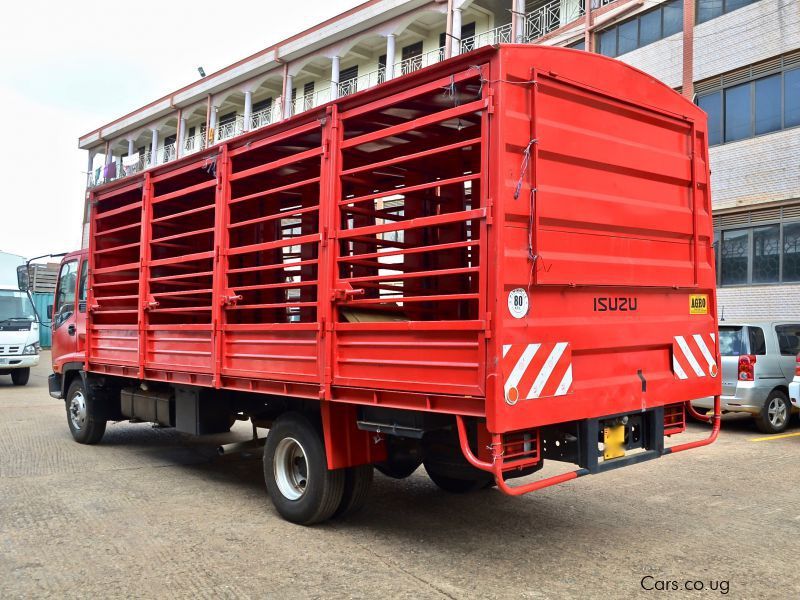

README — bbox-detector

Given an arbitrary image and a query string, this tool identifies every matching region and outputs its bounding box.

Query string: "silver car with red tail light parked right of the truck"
[692,322,800,433]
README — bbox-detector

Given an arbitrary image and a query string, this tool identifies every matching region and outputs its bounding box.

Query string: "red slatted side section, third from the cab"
[220,121,324,390]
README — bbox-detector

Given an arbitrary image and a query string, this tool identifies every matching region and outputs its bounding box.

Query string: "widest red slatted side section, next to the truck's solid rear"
[332,67,489,400]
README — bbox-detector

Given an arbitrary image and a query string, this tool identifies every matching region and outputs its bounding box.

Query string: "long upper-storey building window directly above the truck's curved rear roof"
[596,0,683,57]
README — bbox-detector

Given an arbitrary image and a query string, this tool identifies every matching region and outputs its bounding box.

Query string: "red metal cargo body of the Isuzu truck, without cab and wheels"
[88,46,720,464]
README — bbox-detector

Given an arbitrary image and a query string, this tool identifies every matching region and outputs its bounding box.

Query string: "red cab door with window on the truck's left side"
[52,257,80,373]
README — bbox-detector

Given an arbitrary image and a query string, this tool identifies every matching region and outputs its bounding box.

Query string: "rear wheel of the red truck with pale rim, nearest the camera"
[264,412,345,525]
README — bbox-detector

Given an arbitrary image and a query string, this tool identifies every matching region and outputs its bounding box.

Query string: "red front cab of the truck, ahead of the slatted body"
[49,250,89,398]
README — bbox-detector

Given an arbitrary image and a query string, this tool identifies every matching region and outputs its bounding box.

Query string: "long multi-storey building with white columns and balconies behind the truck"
[79,0,800,318]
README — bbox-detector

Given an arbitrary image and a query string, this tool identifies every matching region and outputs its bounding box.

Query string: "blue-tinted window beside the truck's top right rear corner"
[697,67,800,146]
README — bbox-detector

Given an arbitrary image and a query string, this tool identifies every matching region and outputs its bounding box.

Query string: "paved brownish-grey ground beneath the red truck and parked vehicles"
[0,354,800,599]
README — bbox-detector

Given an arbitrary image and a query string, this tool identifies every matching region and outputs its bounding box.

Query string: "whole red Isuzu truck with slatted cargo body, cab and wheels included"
[50,45,720,524]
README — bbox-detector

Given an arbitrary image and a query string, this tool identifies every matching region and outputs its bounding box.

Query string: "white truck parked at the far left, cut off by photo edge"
[0,252,40,385]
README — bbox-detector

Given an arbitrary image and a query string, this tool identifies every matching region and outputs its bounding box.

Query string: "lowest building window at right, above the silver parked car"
[714,208,800,286]
